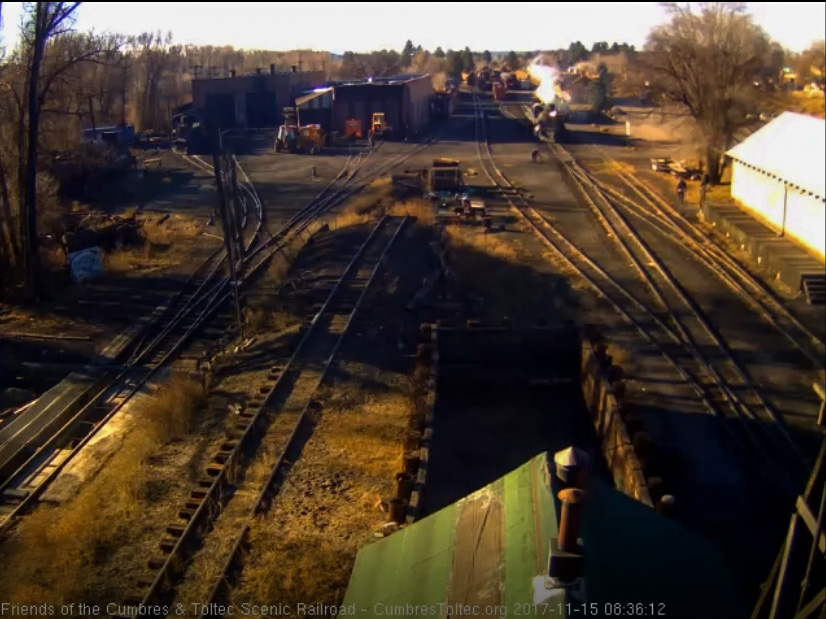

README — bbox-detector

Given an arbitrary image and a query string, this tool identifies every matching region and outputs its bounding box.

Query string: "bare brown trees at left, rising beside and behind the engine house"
[0,2,330,298]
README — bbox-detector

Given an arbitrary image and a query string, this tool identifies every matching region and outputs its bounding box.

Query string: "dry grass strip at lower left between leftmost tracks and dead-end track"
[0,378,205,604]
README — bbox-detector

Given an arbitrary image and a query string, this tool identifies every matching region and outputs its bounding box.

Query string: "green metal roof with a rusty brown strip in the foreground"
[343,453,739,619]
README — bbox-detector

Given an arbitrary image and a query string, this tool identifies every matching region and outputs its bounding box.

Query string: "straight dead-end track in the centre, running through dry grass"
[113,215,408,614]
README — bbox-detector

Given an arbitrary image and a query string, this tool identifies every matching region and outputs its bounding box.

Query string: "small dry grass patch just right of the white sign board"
[104,213,209,274]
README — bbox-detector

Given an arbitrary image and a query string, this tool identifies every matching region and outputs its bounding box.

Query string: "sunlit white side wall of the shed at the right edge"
[731,161,826,258]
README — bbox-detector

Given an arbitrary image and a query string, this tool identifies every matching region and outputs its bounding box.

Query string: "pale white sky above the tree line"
[2,2,826,54]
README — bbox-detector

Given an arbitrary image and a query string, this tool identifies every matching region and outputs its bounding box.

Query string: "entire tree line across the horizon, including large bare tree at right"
[0,2,826,298]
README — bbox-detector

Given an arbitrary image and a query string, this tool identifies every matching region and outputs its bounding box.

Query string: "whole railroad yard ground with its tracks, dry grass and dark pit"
[0,17,826,617]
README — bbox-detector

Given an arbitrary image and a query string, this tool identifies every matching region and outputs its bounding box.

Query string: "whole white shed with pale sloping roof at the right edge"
[727,112,826,260]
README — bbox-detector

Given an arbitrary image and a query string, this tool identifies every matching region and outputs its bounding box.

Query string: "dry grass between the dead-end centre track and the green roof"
[239,372,413,604]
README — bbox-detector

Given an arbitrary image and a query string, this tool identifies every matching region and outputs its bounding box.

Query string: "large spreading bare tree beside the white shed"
[647,2,769,183]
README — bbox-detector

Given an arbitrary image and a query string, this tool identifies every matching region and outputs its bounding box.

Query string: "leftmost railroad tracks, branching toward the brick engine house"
[0,121,448,535]
